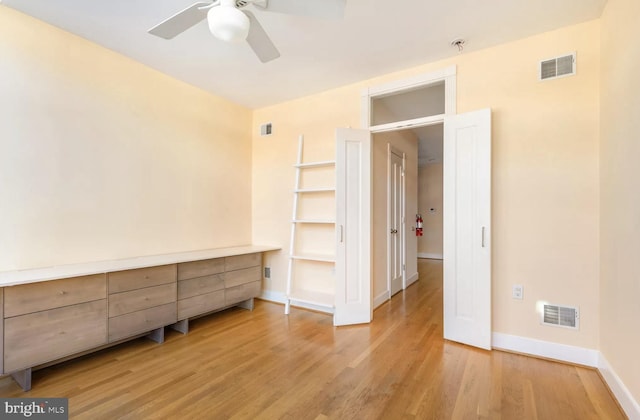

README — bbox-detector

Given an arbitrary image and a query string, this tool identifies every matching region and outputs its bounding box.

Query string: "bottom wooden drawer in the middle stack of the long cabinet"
[109,303,178,343]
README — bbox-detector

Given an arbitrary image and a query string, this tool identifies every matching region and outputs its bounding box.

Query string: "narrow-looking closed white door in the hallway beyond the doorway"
[387,145,404,296]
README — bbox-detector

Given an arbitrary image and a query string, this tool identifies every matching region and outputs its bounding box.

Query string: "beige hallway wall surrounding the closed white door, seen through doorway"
[371,130,418,304]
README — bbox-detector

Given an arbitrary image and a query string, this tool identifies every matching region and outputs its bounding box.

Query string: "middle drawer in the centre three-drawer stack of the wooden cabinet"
[109,283,177,318]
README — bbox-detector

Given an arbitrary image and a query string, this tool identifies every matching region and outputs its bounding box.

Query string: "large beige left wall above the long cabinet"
[0,7,251,270]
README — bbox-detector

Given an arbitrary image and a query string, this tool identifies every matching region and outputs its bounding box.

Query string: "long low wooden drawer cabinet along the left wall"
[0,247,276,391]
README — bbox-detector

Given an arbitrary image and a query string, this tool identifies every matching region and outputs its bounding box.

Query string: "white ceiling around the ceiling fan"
[0,0,606,108]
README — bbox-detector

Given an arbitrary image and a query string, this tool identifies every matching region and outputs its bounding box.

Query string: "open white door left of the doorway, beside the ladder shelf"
[333,128,373,325]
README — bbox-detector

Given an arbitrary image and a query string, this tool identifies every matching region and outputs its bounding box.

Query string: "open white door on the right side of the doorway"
[444,109,491,349]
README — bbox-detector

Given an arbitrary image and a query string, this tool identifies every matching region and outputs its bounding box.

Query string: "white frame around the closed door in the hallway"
[387,143,407,300]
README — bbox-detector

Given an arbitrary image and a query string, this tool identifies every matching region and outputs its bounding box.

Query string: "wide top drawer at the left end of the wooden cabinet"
[4,274,107,318]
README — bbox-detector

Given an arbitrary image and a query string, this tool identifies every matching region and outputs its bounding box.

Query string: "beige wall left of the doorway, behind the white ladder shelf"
[252,87,359,299]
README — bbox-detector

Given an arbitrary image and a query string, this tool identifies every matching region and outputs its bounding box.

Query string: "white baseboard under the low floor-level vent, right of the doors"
[492,332,600,367]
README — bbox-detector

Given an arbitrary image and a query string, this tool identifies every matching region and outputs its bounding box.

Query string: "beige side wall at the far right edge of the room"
[600,0,640,401]
